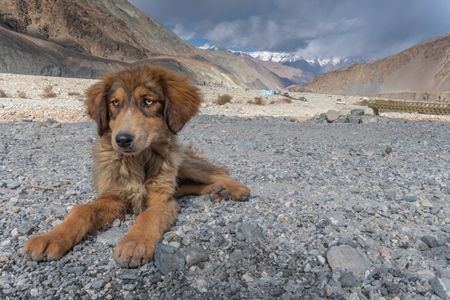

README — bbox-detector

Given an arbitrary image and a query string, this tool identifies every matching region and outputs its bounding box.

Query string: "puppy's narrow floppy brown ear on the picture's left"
[85,80,109,136]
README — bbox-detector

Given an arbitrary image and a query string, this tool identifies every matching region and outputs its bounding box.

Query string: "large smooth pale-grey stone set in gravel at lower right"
[326,245,373,278]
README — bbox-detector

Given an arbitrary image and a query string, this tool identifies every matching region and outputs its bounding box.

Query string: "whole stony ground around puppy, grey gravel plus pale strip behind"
[0,74,450,299]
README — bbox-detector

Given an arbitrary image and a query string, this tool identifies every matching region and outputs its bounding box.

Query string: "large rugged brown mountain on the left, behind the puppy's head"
[0,0,284,89]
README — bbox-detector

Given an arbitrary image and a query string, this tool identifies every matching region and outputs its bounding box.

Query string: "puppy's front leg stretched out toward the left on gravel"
[23,197,126,261]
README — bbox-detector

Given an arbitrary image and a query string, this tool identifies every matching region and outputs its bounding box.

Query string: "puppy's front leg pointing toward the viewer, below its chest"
[113,184,178,268]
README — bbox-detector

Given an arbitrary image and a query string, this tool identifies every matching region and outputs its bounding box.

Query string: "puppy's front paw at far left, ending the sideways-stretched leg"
[23,233,70,261]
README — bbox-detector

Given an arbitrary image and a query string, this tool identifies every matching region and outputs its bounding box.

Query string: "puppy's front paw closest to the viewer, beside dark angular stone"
[113,236,155,268]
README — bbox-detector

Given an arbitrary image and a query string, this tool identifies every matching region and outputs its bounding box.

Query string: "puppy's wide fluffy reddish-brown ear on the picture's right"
[161,69,202,133]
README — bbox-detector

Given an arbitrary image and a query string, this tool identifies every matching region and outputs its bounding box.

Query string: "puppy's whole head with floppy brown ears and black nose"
[86,65,201,154]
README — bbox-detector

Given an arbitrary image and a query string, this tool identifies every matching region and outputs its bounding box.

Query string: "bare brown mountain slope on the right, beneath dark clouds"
[290,35,450,99]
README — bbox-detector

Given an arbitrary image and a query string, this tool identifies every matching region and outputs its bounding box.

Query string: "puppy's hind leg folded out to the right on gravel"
[174,149,250,202]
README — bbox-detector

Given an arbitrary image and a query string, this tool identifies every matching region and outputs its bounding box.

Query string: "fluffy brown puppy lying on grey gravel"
[23,65,250,268]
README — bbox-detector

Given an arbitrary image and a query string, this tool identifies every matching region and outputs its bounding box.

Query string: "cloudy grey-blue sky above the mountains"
[129,0,450,59]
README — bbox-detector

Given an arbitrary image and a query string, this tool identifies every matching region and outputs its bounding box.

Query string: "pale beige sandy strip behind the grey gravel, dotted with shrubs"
[0,74,450,122]
